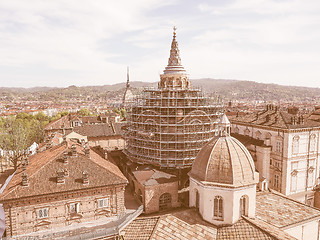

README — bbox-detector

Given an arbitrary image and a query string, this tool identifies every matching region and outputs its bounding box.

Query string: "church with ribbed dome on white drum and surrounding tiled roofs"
[120,116,320,240]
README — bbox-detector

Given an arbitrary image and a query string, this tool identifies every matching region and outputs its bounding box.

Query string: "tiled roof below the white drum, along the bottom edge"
[121,209,295,240]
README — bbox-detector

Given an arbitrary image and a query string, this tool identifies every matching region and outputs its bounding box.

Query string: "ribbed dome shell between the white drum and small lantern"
[190,136,259,186]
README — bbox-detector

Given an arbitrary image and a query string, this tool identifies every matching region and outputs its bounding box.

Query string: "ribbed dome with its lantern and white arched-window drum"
[189,115,259,225]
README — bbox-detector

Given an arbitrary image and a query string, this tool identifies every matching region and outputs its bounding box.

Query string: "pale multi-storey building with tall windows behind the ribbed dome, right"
[230,105,320,205]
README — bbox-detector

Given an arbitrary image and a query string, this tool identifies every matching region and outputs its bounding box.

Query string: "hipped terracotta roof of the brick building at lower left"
[0,143,127,201]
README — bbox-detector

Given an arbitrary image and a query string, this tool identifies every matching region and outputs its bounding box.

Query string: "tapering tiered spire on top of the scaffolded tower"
[163,27,186,74]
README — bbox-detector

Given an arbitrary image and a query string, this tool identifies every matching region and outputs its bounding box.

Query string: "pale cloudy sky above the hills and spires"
[0,0,320,87]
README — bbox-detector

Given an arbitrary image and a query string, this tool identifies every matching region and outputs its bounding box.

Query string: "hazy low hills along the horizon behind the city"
[0,78,320,101]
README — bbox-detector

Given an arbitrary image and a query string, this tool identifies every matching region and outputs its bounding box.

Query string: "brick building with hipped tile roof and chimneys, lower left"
[0,141,128,236]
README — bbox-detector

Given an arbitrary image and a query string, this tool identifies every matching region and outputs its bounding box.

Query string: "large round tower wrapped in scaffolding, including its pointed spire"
[124,29,222,187]
